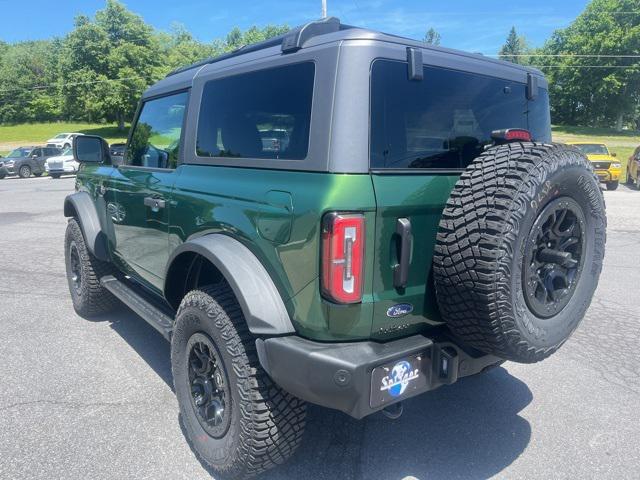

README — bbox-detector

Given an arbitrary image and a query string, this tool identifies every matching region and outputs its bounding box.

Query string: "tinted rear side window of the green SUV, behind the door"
[196,62,315,160]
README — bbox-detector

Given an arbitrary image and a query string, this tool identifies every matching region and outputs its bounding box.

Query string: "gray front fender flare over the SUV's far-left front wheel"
[64,192,110,262]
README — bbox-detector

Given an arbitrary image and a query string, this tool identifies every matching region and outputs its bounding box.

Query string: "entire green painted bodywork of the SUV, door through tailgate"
[77,164,458,341]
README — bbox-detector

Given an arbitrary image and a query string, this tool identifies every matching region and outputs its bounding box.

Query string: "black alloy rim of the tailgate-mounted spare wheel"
[522,197,585,318]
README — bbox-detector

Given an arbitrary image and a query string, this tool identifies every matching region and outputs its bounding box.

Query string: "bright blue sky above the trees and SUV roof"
[0,0,588,54]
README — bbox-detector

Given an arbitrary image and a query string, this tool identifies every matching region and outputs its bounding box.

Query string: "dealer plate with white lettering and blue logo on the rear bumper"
[369,351,431,408]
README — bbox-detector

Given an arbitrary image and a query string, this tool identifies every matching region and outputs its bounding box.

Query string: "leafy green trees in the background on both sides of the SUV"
[0,0,640,129]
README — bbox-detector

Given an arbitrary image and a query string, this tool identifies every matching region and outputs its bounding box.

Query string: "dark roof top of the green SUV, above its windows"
[144,17,543,97]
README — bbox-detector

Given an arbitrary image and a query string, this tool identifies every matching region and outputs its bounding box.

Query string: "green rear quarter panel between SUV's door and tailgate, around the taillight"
[168,165,375,340]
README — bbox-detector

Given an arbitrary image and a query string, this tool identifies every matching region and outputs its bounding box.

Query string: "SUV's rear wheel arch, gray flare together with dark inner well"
[164,233,295,335]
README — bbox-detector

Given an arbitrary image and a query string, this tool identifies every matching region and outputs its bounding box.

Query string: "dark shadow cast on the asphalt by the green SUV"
[96,308,533,480]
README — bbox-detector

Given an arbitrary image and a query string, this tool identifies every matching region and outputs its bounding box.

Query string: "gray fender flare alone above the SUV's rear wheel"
[165,233,295,335]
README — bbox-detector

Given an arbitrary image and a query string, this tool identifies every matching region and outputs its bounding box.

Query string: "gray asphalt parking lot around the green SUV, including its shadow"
[0,178,640,480]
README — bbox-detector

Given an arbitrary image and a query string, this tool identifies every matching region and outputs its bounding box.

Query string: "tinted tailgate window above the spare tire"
[370,60,550,169]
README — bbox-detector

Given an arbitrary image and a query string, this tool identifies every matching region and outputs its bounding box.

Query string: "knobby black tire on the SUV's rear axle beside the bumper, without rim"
[171,282,306,479]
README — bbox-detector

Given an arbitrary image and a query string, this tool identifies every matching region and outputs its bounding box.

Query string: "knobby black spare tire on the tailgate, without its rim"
[433,143,606,363]
